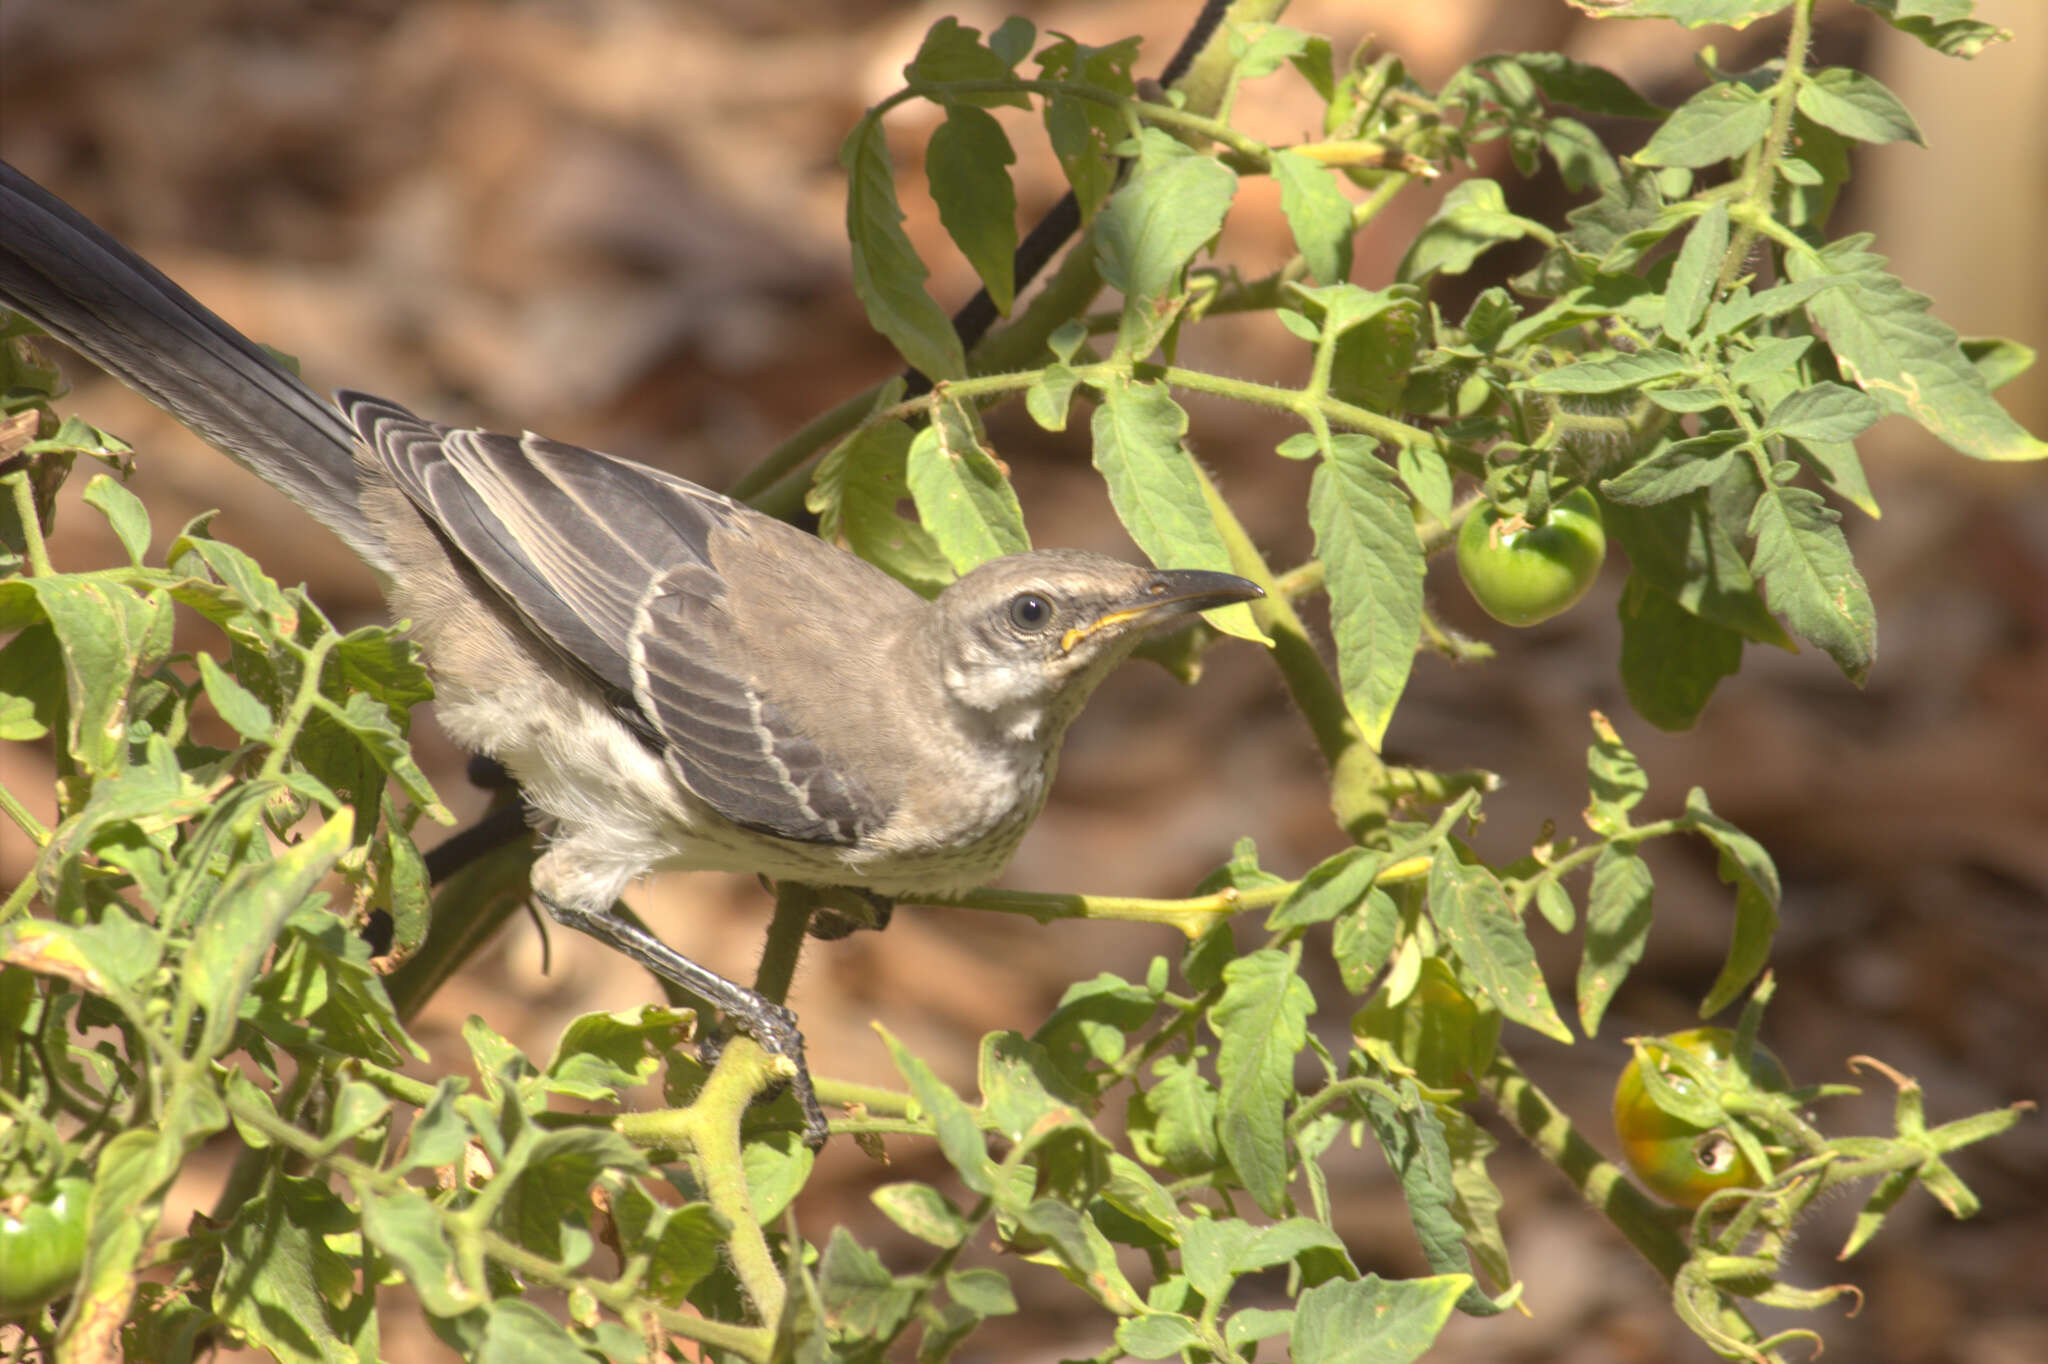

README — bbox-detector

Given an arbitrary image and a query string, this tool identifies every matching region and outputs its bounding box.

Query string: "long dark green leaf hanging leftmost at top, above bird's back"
[840,115,967,379]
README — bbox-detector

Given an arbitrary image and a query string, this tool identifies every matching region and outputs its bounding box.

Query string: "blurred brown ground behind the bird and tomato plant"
[0,0,2048,1364]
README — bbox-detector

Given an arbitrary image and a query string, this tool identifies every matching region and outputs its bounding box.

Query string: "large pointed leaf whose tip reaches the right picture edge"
[1786,233,2048,461]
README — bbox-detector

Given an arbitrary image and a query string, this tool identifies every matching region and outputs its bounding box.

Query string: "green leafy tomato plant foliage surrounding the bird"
[0,0,2048,1364]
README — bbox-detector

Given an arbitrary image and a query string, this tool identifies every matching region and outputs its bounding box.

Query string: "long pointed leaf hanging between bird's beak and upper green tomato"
[1309,434,1427,748]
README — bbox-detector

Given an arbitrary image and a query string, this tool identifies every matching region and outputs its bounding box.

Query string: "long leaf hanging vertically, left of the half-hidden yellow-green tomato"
[1208,948,1315,1217]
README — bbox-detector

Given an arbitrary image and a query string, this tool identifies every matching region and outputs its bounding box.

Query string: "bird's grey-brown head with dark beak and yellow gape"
[932,549,1264,739]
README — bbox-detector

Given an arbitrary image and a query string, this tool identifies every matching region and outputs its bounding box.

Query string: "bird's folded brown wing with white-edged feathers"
[340,393,907,844]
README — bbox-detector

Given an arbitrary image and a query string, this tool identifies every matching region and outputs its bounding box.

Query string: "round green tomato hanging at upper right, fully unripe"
[1458,487,1608,625]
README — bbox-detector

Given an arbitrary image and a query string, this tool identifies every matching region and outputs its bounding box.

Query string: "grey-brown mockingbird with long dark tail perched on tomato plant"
[0,164,1260,1141]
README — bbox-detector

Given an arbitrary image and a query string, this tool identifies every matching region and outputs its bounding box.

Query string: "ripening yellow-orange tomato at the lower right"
[1614,1028,1792,1208]
